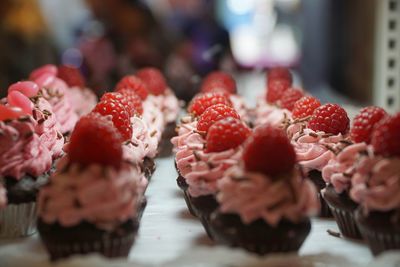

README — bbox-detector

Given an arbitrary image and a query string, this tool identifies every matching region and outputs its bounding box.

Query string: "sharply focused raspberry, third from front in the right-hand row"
[308,104,350,134]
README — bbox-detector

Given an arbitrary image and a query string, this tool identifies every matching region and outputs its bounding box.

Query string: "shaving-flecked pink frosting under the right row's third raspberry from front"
[287,124,345,172]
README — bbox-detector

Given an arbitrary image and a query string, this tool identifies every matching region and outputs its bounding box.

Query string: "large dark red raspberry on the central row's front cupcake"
[243,124,296,176]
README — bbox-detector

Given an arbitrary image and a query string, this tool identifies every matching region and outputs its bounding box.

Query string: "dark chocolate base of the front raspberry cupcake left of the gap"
[38,219,138,261]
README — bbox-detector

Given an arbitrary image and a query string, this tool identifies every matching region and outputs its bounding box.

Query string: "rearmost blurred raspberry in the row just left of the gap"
[136,68,167,95]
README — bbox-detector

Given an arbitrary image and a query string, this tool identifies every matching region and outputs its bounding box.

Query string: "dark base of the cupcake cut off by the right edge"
[354,208,400,256]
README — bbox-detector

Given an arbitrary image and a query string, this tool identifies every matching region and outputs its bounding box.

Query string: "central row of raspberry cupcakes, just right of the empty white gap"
[172,71,319,255]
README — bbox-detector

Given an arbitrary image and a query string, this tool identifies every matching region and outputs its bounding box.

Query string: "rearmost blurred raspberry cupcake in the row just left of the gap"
[136,67,180,157]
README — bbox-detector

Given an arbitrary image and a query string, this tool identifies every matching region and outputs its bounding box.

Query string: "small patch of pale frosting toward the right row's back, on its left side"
[255,96,292,126]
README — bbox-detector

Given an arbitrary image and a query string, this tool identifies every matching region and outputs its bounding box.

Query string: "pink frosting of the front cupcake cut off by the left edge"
[0,117,52,180]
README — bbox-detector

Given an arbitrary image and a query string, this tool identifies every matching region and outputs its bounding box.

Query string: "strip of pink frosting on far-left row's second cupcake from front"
[33,97,65,159]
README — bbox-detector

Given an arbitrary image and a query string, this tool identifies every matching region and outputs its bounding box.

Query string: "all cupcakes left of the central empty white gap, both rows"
[0,65,179,259]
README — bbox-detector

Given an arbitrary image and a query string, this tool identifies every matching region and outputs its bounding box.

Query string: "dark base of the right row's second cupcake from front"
[323,185,362,240]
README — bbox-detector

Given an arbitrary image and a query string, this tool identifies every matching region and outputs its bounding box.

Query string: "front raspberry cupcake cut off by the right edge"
[350,113,400,255]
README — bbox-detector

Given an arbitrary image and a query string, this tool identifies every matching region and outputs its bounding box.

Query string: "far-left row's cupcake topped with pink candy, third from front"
[29,65,78,135]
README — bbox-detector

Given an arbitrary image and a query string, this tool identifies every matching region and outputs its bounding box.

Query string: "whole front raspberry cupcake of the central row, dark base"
[208,125,319,255]
